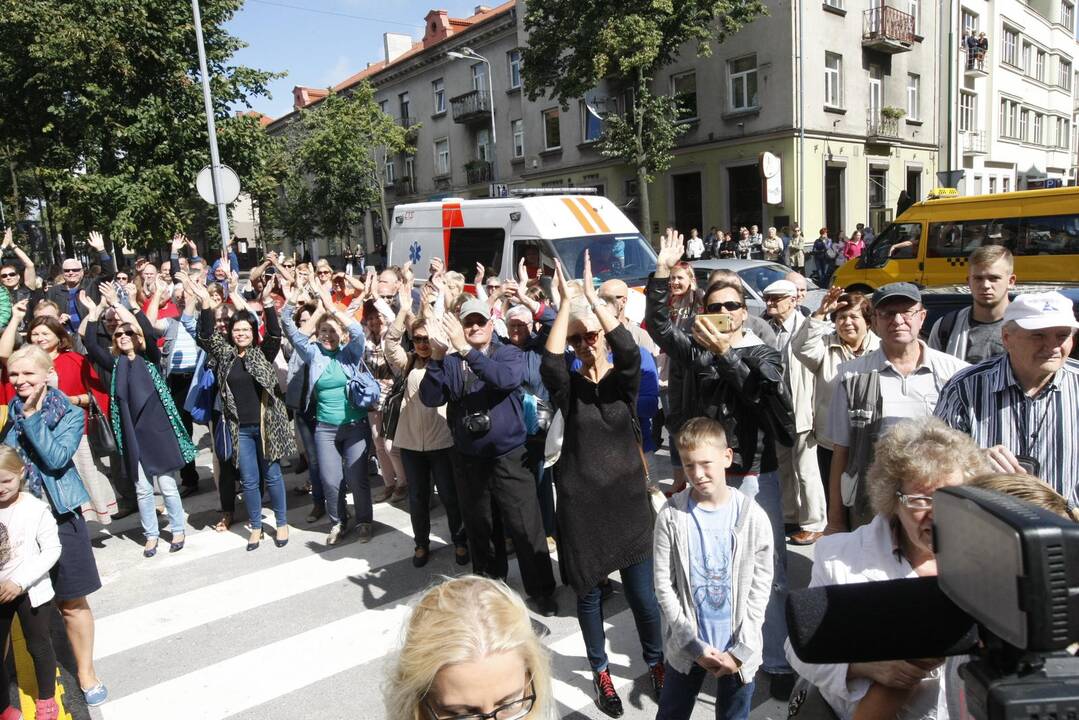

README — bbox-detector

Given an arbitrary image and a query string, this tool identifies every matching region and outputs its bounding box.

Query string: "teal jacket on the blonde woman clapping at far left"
[3,403,90,515]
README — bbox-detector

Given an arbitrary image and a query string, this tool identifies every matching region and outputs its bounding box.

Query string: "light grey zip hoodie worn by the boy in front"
[653,488,773,683]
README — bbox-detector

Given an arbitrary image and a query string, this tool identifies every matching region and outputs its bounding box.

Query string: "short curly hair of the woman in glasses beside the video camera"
[866,417,989,518]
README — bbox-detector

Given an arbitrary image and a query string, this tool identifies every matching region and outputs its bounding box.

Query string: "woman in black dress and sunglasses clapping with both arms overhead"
[540,250,664,717]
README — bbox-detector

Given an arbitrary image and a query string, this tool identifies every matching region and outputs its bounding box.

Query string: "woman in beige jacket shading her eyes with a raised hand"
[791,287,880,487]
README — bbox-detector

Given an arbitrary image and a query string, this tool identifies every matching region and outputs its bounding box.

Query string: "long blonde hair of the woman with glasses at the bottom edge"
[383,575,551,720]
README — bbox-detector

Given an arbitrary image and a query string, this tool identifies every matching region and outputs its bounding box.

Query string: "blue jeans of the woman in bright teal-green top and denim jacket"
[315,418,374,525]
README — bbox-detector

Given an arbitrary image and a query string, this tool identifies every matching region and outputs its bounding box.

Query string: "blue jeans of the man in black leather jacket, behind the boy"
[727,471,794,675]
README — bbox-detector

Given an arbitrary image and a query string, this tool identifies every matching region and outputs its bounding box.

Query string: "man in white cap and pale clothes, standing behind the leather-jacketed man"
[763,280,828,545]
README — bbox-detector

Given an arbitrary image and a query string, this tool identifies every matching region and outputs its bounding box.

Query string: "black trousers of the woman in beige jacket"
[401,448,467,548]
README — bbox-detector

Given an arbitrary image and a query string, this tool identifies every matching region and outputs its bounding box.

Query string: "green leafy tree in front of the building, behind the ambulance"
[522,0,765,234]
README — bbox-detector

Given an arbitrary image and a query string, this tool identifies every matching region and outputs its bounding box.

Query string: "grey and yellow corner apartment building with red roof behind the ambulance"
[271,0,940,253]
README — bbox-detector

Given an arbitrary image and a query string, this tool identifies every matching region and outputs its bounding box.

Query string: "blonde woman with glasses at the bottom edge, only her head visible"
[383,575,555,720]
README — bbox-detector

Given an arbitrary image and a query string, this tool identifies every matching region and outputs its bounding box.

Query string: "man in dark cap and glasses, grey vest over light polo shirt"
[828,283,967,532]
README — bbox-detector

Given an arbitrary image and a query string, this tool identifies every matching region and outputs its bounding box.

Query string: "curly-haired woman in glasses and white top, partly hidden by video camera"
[787,418,987,720]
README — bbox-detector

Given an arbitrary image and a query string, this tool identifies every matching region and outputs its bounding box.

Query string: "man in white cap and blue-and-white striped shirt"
[937,293,1079,504]
